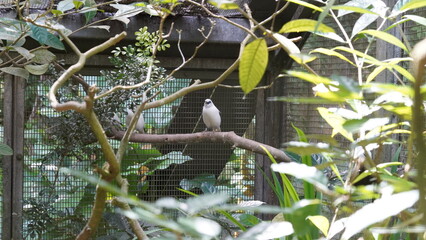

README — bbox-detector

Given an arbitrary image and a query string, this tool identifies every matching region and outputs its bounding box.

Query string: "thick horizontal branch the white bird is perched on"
[111,131,291,162]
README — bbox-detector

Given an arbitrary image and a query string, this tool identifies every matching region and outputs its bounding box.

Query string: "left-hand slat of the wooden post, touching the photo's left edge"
[2,74,13,239]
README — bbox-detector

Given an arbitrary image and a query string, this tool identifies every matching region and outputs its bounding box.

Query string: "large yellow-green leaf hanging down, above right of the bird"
[239,38,268,94]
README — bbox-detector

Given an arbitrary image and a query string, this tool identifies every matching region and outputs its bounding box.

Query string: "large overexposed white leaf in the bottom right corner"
[342,190,419,239]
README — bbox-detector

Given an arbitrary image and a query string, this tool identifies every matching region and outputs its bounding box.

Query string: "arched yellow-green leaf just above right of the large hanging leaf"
[279,19,334,33]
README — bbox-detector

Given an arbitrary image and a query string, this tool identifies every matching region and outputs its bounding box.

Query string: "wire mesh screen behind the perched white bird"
[23,76,255,239]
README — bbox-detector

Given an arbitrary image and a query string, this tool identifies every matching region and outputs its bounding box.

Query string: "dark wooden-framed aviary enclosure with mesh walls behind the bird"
[1,0,314,239]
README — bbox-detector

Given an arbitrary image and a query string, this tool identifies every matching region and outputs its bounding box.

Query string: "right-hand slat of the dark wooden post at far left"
[12,77,25,239]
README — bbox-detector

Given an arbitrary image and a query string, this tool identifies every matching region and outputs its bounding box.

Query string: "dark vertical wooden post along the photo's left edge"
[2,74,25,239]
